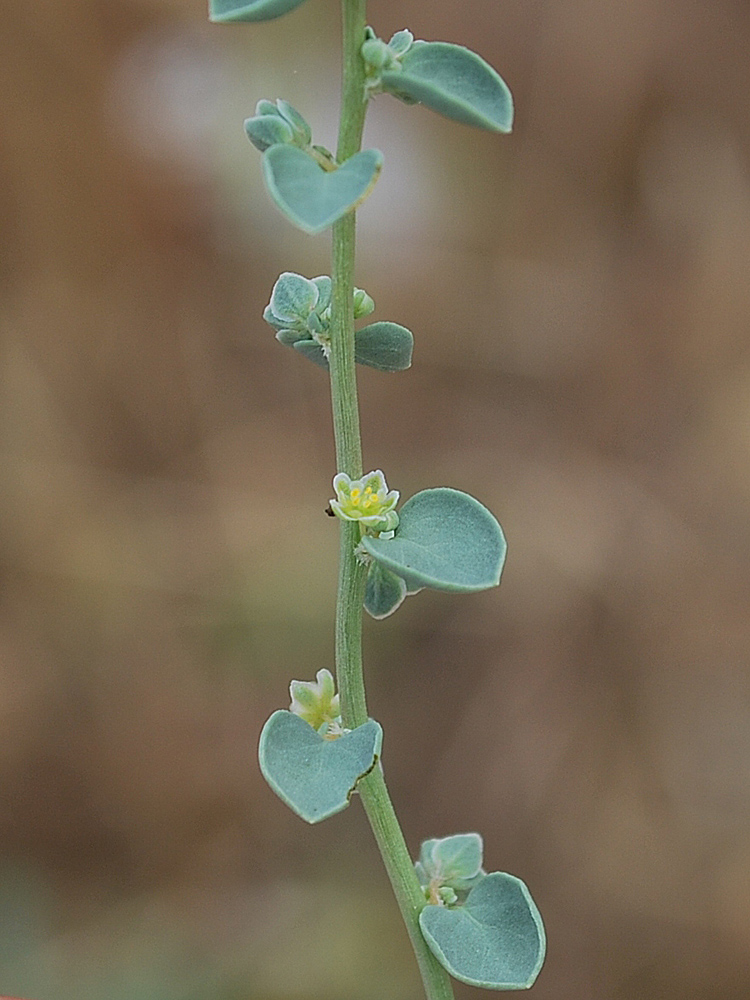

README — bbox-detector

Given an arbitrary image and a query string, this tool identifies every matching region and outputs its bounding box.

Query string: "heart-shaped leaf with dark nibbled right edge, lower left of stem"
[258,709,383,823]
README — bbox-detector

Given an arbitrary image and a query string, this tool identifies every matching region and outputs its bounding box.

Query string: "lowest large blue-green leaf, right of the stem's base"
[419,872,546,990]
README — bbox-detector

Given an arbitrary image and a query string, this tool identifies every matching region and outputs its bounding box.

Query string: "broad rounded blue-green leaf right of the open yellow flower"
[362,487,507,592]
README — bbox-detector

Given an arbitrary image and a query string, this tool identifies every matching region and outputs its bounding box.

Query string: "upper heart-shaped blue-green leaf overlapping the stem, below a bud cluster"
[263,146,383,233]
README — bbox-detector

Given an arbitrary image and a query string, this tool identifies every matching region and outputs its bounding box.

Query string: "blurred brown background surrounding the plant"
[0,0,750,1000]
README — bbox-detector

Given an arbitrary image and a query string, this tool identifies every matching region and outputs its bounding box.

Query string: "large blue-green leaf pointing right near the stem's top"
[381,42,513,132]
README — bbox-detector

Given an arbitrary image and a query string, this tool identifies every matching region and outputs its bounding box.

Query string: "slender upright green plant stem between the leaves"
[329,7,453,1000]
